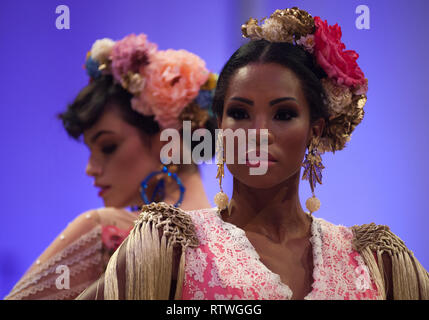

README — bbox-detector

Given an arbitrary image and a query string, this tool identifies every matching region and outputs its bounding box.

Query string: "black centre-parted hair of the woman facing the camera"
[213,40,328,121]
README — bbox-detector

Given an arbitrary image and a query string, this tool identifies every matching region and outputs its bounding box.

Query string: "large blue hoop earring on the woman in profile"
[140,166,185,207]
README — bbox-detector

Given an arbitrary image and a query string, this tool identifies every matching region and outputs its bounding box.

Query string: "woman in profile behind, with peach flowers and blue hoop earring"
[6,34,216,299]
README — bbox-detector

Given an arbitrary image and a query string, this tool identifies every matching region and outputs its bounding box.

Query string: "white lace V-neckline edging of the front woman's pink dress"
[215,209,322,300]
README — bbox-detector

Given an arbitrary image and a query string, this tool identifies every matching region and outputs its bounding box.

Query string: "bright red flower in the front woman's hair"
[314,17,365,87]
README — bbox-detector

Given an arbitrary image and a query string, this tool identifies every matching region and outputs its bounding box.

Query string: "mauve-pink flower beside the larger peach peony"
[110,34,157,84]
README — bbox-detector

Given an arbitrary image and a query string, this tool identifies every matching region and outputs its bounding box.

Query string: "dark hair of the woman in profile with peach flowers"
[59,75,217,158]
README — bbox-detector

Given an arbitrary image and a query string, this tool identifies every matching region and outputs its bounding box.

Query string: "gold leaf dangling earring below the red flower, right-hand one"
[302,137,325,214]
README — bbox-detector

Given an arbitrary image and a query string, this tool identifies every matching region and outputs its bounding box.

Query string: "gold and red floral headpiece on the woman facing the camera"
[241,7,368,153]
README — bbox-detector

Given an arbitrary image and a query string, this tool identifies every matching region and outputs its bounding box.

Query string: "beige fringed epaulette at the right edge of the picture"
[352,223,429,300]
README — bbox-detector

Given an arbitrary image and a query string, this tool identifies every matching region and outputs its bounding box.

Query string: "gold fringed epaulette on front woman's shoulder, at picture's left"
[104,202,199,300]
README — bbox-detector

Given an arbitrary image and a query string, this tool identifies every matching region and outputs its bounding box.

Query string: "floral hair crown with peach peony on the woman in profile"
[85,34,217,129]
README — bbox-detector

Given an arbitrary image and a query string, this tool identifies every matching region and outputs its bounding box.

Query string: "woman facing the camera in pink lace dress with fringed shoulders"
[79,8,429,299]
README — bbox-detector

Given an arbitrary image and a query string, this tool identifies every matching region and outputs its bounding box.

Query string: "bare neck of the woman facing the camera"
[222,171,311,243]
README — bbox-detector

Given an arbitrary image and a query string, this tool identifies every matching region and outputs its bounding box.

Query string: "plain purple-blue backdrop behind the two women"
[0,0,429,297]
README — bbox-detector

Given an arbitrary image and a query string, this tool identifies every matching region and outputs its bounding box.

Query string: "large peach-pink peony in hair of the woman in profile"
[133,49,209,128]
